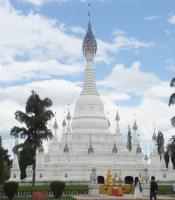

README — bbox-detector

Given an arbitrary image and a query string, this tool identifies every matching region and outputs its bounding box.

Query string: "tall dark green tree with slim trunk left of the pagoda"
[11,91,54,191]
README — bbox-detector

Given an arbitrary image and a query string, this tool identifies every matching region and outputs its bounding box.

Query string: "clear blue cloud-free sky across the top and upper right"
[11,0,175,80]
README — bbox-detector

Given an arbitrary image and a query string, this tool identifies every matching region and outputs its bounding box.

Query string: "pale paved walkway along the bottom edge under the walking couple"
[74,195,175,200]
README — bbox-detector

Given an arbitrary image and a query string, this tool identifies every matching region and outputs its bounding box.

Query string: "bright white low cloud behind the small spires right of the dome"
[104,97,174,147]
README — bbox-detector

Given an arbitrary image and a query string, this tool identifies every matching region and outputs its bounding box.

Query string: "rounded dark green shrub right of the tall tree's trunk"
[50,181,65,198]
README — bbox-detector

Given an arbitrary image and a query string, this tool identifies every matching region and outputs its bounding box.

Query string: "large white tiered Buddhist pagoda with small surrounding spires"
[11,18,175,182]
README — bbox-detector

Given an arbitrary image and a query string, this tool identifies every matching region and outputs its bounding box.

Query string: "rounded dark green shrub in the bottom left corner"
[3,181,18,199]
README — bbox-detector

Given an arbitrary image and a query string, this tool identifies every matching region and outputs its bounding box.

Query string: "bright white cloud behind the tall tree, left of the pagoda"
[0,80,80,139]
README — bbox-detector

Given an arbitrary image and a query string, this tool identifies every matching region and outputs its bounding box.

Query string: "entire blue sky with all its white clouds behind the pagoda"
[0,0,175,153]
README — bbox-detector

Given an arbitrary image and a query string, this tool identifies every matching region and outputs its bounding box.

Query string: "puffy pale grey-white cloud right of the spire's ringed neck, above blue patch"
[100,61,161,95]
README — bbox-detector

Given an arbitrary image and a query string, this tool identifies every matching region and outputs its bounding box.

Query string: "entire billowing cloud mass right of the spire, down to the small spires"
[99,61,174,146]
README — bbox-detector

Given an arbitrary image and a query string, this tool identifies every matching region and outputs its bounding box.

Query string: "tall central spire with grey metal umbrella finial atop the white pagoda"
[81,2,98,95]
